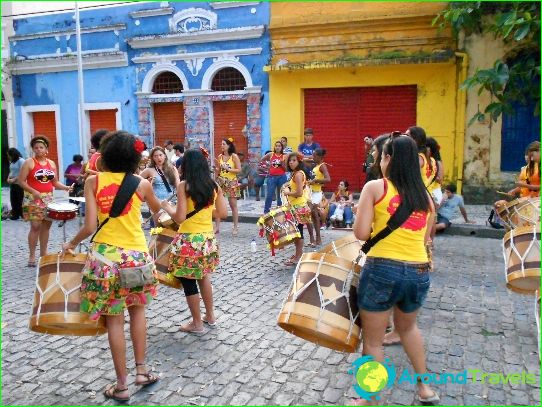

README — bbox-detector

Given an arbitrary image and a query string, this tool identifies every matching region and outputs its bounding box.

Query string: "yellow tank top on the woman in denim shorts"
[367,178,429,263]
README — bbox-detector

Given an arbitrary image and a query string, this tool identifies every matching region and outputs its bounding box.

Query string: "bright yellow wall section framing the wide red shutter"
[269,60,457,183]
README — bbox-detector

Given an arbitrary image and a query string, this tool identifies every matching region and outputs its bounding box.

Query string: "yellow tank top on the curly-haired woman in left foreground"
[94,172,149,252]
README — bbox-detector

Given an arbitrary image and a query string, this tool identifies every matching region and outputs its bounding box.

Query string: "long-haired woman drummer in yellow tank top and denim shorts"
[354,136,438,402]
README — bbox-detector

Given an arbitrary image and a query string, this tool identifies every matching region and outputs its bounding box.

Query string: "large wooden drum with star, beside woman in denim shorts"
[277,253,361,352]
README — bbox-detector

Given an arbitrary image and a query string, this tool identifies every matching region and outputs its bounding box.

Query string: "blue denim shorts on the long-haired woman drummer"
[358,257,431,313]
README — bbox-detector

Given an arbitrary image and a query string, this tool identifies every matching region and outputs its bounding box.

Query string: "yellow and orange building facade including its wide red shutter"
[266,2,467,190]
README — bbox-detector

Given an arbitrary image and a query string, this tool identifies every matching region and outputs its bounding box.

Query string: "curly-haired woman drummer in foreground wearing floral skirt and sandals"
[62,131,160,401]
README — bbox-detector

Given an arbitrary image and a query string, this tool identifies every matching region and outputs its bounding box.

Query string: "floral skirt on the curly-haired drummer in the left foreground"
[80,243,158,320]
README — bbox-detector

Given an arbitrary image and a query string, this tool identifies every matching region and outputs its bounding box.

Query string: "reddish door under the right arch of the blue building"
[213,100,248,157]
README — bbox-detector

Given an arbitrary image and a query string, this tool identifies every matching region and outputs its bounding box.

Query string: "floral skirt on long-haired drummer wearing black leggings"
[169,232,218,280]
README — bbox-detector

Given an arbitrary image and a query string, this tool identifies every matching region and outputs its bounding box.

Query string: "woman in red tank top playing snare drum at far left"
[17,136,72,267]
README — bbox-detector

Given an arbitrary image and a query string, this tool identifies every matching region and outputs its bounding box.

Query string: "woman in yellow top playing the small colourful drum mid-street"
[282,153,312,266]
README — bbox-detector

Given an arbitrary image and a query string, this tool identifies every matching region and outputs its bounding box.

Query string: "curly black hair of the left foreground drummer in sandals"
[100,130,141,173]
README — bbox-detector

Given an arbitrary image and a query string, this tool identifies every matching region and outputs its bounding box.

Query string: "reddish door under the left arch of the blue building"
[153,103,184,147]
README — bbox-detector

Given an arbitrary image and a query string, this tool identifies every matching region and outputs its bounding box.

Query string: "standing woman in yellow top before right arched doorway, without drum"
[215,138,241,236]
